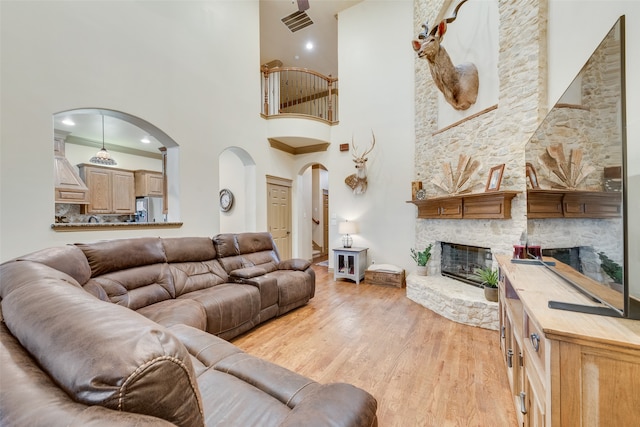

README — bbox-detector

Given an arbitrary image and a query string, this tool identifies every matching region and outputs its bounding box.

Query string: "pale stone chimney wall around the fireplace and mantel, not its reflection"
[414,0,548,273]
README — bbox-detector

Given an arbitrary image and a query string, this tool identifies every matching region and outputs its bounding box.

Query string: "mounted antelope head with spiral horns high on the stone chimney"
[412,0,480,110]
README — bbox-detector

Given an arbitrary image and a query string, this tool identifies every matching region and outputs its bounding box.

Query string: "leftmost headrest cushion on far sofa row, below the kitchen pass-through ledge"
[76,237,167,277]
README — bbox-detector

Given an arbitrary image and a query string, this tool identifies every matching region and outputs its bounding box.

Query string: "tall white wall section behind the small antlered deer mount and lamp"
[321,0,415,268]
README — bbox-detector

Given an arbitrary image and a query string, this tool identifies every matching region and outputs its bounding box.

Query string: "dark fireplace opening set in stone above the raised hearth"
[440,242,493,287]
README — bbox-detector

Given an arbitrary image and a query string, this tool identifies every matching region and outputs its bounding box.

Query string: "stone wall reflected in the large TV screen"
[526,21,624,270]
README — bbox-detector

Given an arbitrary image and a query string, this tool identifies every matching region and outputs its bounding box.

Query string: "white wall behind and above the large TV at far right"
[548,0,640,296]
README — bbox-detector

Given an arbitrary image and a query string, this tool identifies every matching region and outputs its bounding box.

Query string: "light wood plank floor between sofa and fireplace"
[233,266,517,427]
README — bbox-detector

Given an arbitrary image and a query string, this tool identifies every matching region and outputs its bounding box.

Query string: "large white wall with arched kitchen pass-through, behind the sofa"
[0,0,292,260]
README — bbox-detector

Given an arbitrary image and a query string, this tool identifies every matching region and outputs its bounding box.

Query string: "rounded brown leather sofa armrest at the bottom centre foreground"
[280,383,378,427]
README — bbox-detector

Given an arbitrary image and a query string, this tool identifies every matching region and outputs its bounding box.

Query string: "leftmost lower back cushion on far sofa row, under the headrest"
[84,264,176,310]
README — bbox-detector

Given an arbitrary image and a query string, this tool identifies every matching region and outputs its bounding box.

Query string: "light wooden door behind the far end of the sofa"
[267,179,292,259]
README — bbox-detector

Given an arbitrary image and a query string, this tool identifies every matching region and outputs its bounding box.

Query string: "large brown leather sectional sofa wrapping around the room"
[0,233,377,427]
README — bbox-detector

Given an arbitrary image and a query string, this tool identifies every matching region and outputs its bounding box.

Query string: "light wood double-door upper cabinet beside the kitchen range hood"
[78,164,135,215]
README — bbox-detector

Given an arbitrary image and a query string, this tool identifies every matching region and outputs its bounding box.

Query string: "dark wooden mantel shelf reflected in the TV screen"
[527,189,622,219]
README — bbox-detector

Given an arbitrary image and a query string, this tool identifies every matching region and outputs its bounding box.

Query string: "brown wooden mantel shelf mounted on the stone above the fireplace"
[407,191,520,219]
